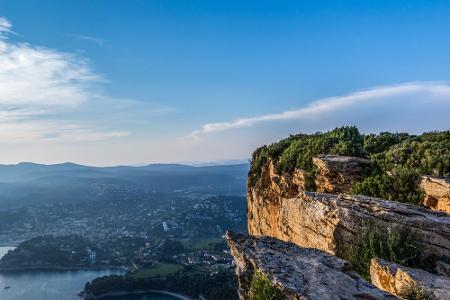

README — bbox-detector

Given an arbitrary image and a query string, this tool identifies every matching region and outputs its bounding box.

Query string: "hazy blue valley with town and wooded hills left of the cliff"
[0,166,247,299]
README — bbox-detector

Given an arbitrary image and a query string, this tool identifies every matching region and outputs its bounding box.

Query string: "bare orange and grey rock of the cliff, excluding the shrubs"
[237,155,450,299]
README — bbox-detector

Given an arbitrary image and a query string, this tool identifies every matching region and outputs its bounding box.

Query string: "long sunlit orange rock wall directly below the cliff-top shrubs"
[247,159,450,259]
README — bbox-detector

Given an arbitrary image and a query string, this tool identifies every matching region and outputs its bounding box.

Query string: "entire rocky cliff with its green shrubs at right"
[228,127,450,300]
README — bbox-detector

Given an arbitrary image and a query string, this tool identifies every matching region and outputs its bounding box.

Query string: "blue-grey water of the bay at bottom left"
[0,247,181,300]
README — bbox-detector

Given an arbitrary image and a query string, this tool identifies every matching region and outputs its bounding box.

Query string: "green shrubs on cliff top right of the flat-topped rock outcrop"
[353,131,450,205]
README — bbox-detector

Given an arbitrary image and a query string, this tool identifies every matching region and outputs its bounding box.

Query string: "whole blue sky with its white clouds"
[0,0,450,165]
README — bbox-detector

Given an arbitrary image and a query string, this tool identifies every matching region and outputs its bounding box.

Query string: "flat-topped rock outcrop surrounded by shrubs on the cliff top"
[313,155,370,194]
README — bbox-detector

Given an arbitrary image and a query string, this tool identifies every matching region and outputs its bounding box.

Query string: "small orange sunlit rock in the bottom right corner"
[370,258,450,299]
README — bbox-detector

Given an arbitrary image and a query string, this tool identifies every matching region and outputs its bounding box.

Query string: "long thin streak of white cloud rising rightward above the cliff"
[188,82,450,139]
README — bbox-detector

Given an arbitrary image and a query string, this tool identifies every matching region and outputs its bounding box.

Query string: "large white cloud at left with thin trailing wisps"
[0,17,170,143]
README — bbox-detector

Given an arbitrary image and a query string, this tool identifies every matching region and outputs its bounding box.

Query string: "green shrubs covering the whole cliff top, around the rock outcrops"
[249,126,450,205]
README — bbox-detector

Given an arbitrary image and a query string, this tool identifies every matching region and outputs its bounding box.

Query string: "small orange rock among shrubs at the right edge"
[420,176,450,214]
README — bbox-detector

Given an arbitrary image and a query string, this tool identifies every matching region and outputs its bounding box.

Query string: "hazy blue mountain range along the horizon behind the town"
[0,162,249,209]
